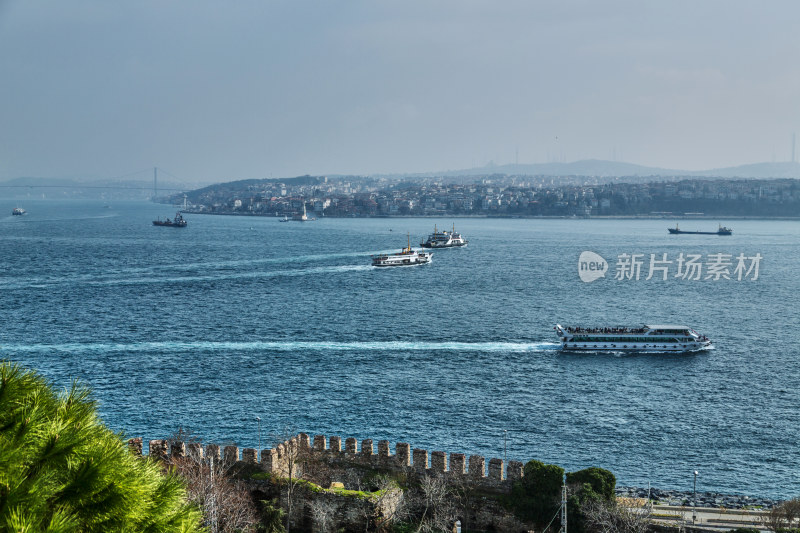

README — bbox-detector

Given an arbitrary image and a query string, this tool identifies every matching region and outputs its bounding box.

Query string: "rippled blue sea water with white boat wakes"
[0,200,800,497]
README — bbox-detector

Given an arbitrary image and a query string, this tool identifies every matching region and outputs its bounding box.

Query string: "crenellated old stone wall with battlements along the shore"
[133,433,523,492]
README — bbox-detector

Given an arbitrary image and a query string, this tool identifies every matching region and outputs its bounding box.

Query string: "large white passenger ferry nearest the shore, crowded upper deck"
[555,324,713,352]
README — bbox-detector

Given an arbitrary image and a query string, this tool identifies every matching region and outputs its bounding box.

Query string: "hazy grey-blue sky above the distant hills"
[0,0,800,181]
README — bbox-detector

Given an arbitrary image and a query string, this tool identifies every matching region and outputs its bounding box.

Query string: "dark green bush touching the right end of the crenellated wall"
[510,460,564,527]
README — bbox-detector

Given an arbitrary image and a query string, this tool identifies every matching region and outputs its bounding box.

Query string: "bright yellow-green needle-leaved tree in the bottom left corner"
[0,362,200,533]
